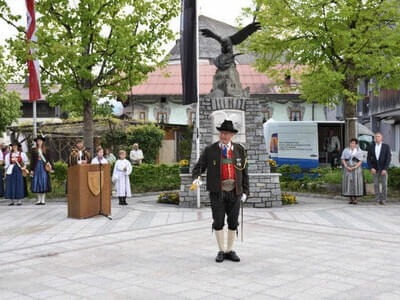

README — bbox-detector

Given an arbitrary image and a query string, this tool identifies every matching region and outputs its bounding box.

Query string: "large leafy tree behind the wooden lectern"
[4,0,180,154]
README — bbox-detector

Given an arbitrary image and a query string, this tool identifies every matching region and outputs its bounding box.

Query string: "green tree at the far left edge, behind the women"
[0,46,21,133]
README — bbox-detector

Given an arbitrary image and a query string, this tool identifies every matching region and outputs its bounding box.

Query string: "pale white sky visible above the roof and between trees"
[0,0,252,49]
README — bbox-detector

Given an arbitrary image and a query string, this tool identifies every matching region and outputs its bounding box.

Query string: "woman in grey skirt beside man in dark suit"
[341,138,365,204]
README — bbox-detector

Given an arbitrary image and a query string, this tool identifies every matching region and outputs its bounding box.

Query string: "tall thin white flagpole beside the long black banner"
[196,0,201,208]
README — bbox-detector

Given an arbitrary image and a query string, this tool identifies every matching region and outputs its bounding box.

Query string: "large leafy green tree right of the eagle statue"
[245,0,400,141]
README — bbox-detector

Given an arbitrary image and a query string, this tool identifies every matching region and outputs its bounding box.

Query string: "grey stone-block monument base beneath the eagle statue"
[179,97,282,207]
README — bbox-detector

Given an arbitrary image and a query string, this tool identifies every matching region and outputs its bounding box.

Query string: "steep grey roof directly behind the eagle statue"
[169,16,255,65]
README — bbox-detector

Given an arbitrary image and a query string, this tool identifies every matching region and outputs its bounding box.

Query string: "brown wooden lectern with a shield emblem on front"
[67,164,111,219]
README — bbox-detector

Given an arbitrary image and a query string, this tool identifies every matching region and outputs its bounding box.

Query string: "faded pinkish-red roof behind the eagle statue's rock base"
[132,64,298,96]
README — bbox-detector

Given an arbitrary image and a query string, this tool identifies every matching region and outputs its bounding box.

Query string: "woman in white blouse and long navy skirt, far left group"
[5,142,28,205]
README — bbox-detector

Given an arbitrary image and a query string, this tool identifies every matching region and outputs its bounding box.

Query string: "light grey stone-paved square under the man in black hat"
[0,196,400,300]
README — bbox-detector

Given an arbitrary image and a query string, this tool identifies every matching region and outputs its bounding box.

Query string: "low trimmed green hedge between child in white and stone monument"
[130,164,181,192]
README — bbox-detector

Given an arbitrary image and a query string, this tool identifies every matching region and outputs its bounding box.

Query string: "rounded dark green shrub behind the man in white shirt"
[126,124,165,164]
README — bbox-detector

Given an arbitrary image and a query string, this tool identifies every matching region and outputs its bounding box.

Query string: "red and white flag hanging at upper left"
[25,0,42,102]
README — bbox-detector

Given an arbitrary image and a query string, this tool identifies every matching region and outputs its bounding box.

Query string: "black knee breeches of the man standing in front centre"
[210,190,240,230]
